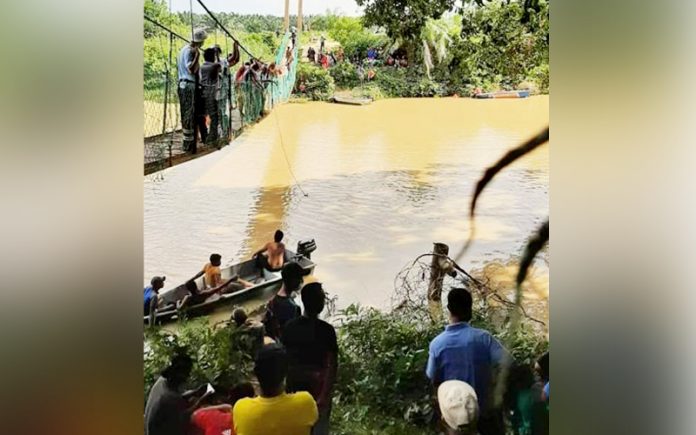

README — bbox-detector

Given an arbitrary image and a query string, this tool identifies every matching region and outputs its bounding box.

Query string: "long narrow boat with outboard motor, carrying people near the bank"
[143,244,316,324]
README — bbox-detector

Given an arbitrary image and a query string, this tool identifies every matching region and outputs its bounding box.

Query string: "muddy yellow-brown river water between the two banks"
[144,96,549,324]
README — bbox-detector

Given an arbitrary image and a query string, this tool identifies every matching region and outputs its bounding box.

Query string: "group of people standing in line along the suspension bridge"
[177,29,297,154]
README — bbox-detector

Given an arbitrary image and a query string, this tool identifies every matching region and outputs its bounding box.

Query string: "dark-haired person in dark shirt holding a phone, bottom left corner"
[145,352,215,435]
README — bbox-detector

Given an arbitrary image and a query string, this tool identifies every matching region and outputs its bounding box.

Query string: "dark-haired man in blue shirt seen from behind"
[426,288,509,435]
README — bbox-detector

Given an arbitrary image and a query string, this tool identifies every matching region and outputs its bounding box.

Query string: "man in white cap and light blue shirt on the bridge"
[177,29,208,153]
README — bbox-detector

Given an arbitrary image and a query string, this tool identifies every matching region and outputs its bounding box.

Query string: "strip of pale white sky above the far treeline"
[171,0,360,16]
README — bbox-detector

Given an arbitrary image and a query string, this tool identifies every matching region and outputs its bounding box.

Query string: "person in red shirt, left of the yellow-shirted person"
[191,382,254,435]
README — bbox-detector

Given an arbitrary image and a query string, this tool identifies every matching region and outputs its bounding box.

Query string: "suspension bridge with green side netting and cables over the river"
[143,0,302,175]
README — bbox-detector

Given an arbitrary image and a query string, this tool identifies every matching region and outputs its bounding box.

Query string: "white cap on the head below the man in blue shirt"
[437,381,478,435]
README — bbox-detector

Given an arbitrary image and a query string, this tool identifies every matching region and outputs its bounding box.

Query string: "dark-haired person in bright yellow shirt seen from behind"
[232,343,319,435]
